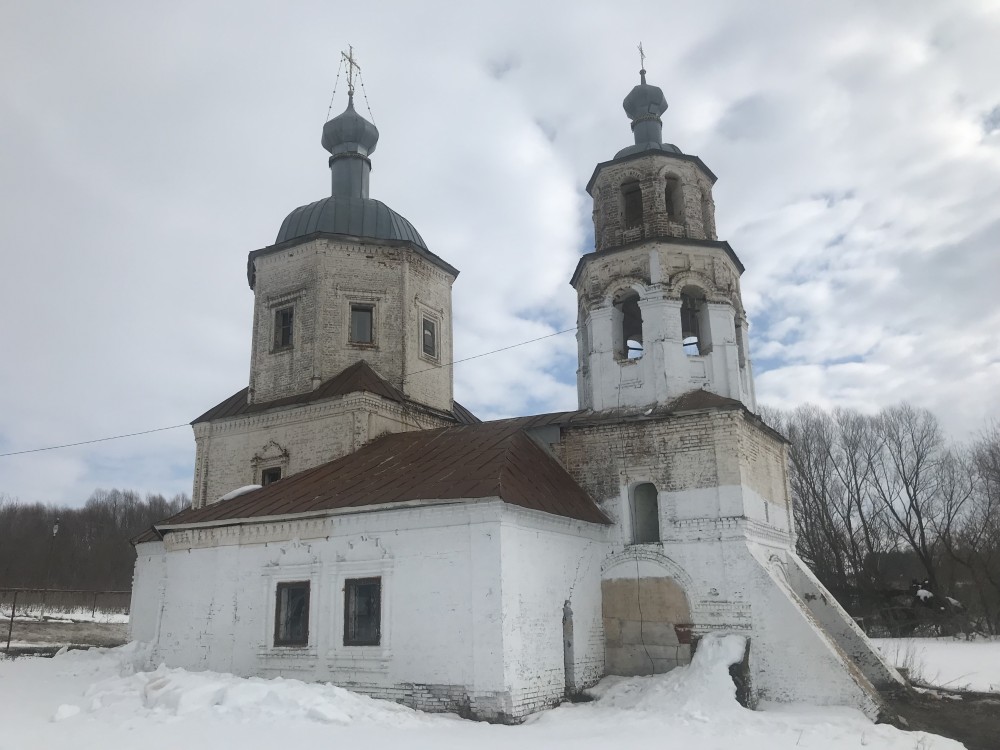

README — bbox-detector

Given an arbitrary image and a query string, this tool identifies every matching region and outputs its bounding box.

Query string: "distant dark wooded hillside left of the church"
[0,489,191,591]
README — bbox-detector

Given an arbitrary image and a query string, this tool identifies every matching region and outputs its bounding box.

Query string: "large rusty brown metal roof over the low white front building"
[143,420,609,541]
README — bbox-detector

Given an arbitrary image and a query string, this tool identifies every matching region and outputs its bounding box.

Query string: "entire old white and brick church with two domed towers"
[131,58,901,723]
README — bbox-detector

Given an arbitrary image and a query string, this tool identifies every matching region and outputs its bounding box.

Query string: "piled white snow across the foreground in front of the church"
[0,636,962,750]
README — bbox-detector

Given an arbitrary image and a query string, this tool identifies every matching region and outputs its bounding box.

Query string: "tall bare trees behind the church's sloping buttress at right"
[762,404,1000,634]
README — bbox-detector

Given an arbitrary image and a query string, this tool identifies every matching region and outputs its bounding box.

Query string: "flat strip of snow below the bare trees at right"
[872,638,1000,693]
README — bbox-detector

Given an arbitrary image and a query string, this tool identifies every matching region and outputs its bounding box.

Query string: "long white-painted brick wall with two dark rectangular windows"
[131,501,508,717]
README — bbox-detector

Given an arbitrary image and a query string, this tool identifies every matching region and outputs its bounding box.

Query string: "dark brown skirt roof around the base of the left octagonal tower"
[191,359,479,424]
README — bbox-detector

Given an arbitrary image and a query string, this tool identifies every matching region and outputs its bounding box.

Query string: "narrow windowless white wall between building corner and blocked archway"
[501,505,608,715]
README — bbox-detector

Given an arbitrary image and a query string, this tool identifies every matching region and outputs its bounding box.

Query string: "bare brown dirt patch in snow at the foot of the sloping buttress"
[884,689,1000,750]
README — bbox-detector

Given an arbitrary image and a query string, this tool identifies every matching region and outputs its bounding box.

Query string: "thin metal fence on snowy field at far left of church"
[0,588,132,654]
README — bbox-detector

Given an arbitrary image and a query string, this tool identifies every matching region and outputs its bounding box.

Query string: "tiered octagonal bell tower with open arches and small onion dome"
[570,70,756,411]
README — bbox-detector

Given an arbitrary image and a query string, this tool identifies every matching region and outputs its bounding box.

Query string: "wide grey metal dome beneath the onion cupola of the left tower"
[274,196,427,250]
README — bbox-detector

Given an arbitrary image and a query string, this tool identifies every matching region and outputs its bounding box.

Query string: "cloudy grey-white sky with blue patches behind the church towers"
[0,0,1000,505]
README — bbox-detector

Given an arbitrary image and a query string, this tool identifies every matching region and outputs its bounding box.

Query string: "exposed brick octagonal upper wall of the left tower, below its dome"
[250,239,454,410]
